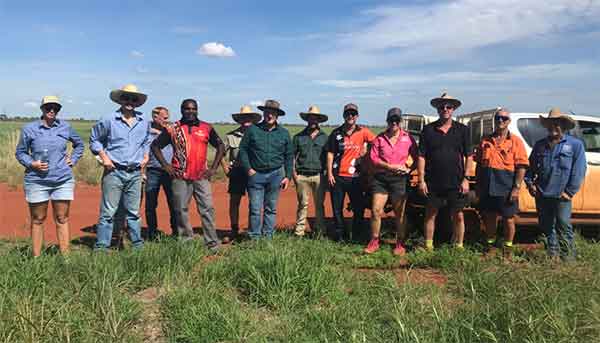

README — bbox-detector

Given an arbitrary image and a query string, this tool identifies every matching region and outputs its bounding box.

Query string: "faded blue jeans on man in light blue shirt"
[95,169,144,250]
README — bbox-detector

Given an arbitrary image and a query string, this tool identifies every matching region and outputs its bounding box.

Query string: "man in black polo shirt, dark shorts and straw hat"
[417,93,473,250]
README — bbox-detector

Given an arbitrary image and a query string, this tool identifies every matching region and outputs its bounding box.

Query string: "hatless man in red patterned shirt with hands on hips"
[152,99,225,253]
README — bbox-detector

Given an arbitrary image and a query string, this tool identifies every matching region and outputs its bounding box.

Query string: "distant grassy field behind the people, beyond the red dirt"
[0,121,381,186]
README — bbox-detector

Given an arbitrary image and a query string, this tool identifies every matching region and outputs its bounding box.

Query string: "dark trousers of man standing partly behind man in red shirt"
[146,168,177,238]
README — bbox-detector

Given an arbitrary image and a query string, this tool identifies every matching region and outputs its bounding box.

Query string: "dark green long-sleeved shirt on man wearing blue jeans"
[239,123,294,179]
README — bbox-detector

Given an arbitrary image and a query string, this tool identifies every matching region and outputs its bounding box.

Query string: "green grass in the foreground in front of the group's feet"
[0,234,600,343]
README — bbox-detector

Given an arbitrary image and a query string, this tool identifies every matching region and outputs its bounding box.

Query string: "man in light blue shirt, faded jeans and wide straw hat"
[90,85,151,250]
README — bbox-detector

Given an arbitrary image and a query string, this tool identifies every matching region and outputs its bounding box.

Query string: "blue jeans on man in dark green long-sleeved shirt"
[248,168,283,239]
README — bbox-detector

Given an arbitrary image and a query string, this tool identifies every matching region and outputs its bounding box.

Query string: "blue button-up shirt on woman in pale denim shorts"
[15,119,83,184]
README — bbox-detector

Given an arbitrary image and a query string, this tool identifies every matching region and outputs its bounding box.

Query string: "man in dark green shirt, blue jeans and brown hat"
[239,100,294,239]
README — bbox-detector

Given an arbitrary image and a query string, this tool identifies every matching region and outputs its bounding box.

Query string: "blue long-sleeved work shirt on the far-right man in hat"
[525,134,587,198]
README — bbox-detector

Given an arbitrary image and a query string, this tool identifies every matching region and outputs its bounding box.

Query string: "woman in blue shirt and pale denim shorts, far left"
[16,96,83,257]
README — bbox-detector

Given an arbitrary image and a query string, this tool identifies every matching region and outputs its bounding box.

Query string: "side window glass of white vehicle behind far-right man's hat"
[517,118,600,152]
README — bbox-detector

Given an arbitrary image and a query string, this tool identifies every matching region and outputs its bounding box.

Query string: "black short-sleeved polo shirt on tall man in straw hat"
[419,120,472,192]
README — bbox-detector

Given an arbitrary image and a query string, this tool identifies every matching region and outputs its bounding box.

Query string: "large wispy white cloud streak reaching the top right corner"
[292,0,600,77]
